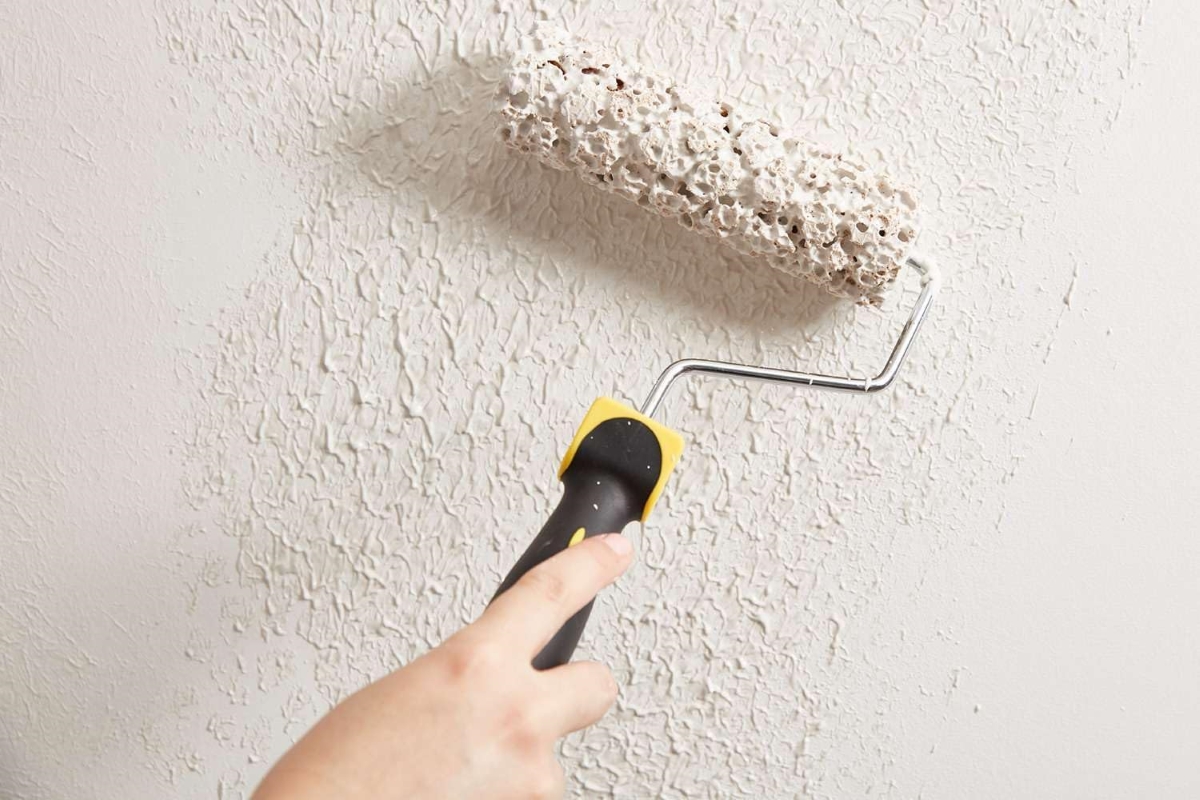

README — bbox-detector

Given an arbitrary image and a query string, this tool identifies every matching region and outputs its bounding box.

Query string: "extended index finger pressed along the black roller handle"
[475,534,634,655]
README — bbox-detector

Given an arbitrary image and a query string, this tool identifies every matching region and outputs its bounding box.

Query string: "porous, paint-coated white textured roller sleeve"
[498,26,917,305]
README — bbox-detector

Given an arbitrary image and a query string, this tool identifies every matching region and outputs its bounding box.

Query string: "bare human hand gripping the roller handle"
[254,534,632,800]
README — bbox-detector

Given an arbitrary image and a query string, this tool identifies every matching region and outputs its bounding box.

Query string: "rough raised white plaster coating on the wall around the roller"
[133,0,1144,798]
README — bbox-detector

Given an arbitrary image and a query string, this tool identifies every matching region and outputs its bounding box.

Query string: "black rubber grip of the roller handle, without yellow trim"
[492,417,664,669]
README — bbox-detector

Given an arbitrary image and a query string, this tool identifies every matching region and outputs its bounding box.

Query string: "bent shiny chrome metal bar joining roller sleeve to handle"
[641,255,941,416]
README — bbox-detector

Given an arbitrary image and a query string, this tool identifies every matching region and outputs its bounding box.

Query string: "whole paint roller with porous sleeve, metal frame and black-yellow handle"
[493,25,938,669]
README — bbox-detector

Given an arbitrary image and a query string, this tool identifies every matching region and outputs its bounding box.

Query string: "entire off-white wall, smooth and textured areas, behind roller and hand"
[0,0,1200,800]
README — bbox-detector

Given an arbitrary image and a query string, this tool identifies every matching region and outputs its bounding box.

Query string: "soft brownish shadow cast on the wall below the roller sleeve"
[331,54,853,347]
